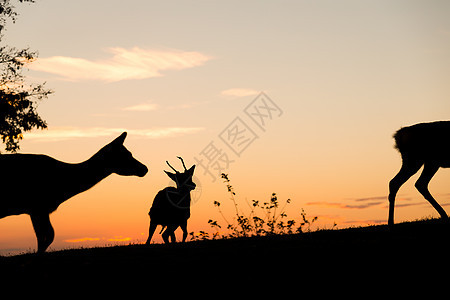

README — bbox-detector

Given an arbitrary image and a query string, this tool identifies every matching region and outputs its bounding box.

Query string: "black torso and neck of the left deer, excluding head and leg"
[0,154,111,217]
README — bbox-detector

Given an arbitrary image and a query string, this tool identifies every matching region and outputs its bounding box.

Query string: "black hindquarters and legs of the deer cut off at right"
[388,121,450,225]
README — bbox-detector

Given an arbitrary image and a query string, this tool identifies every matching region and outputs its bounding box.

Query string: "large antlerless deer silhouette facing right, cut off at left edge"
[0,132,148,252]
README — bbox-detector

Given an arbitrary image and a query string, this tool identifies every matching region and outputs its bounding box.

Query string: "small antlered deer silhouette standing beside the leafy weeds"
[145,156,196,245]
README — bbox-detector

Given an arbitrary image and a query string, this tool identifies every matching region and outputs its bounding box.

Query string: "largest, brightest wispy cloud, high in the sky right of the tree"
[29,47,211,82]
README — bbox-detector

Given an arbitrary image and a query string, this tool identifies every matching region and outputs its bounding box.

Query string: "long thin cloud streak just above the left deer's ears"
[25,127,204,142]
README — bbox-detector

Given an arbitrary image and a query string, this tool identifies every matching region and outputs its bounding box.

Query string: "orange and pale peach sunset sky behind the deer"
[0,0,450,254]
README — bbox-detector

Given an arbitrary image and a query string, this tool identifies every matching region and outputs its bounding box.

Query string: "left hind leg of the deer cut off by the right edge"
[388,160,423,225]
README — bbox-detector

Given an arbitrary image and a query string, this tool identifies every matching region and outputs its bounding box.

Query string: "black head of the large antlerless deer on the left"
[94,132,148,177]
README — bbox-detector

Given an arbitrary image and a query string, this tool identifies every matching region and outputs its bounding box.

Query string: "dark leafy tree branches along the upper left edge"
[0,0,52,152]
